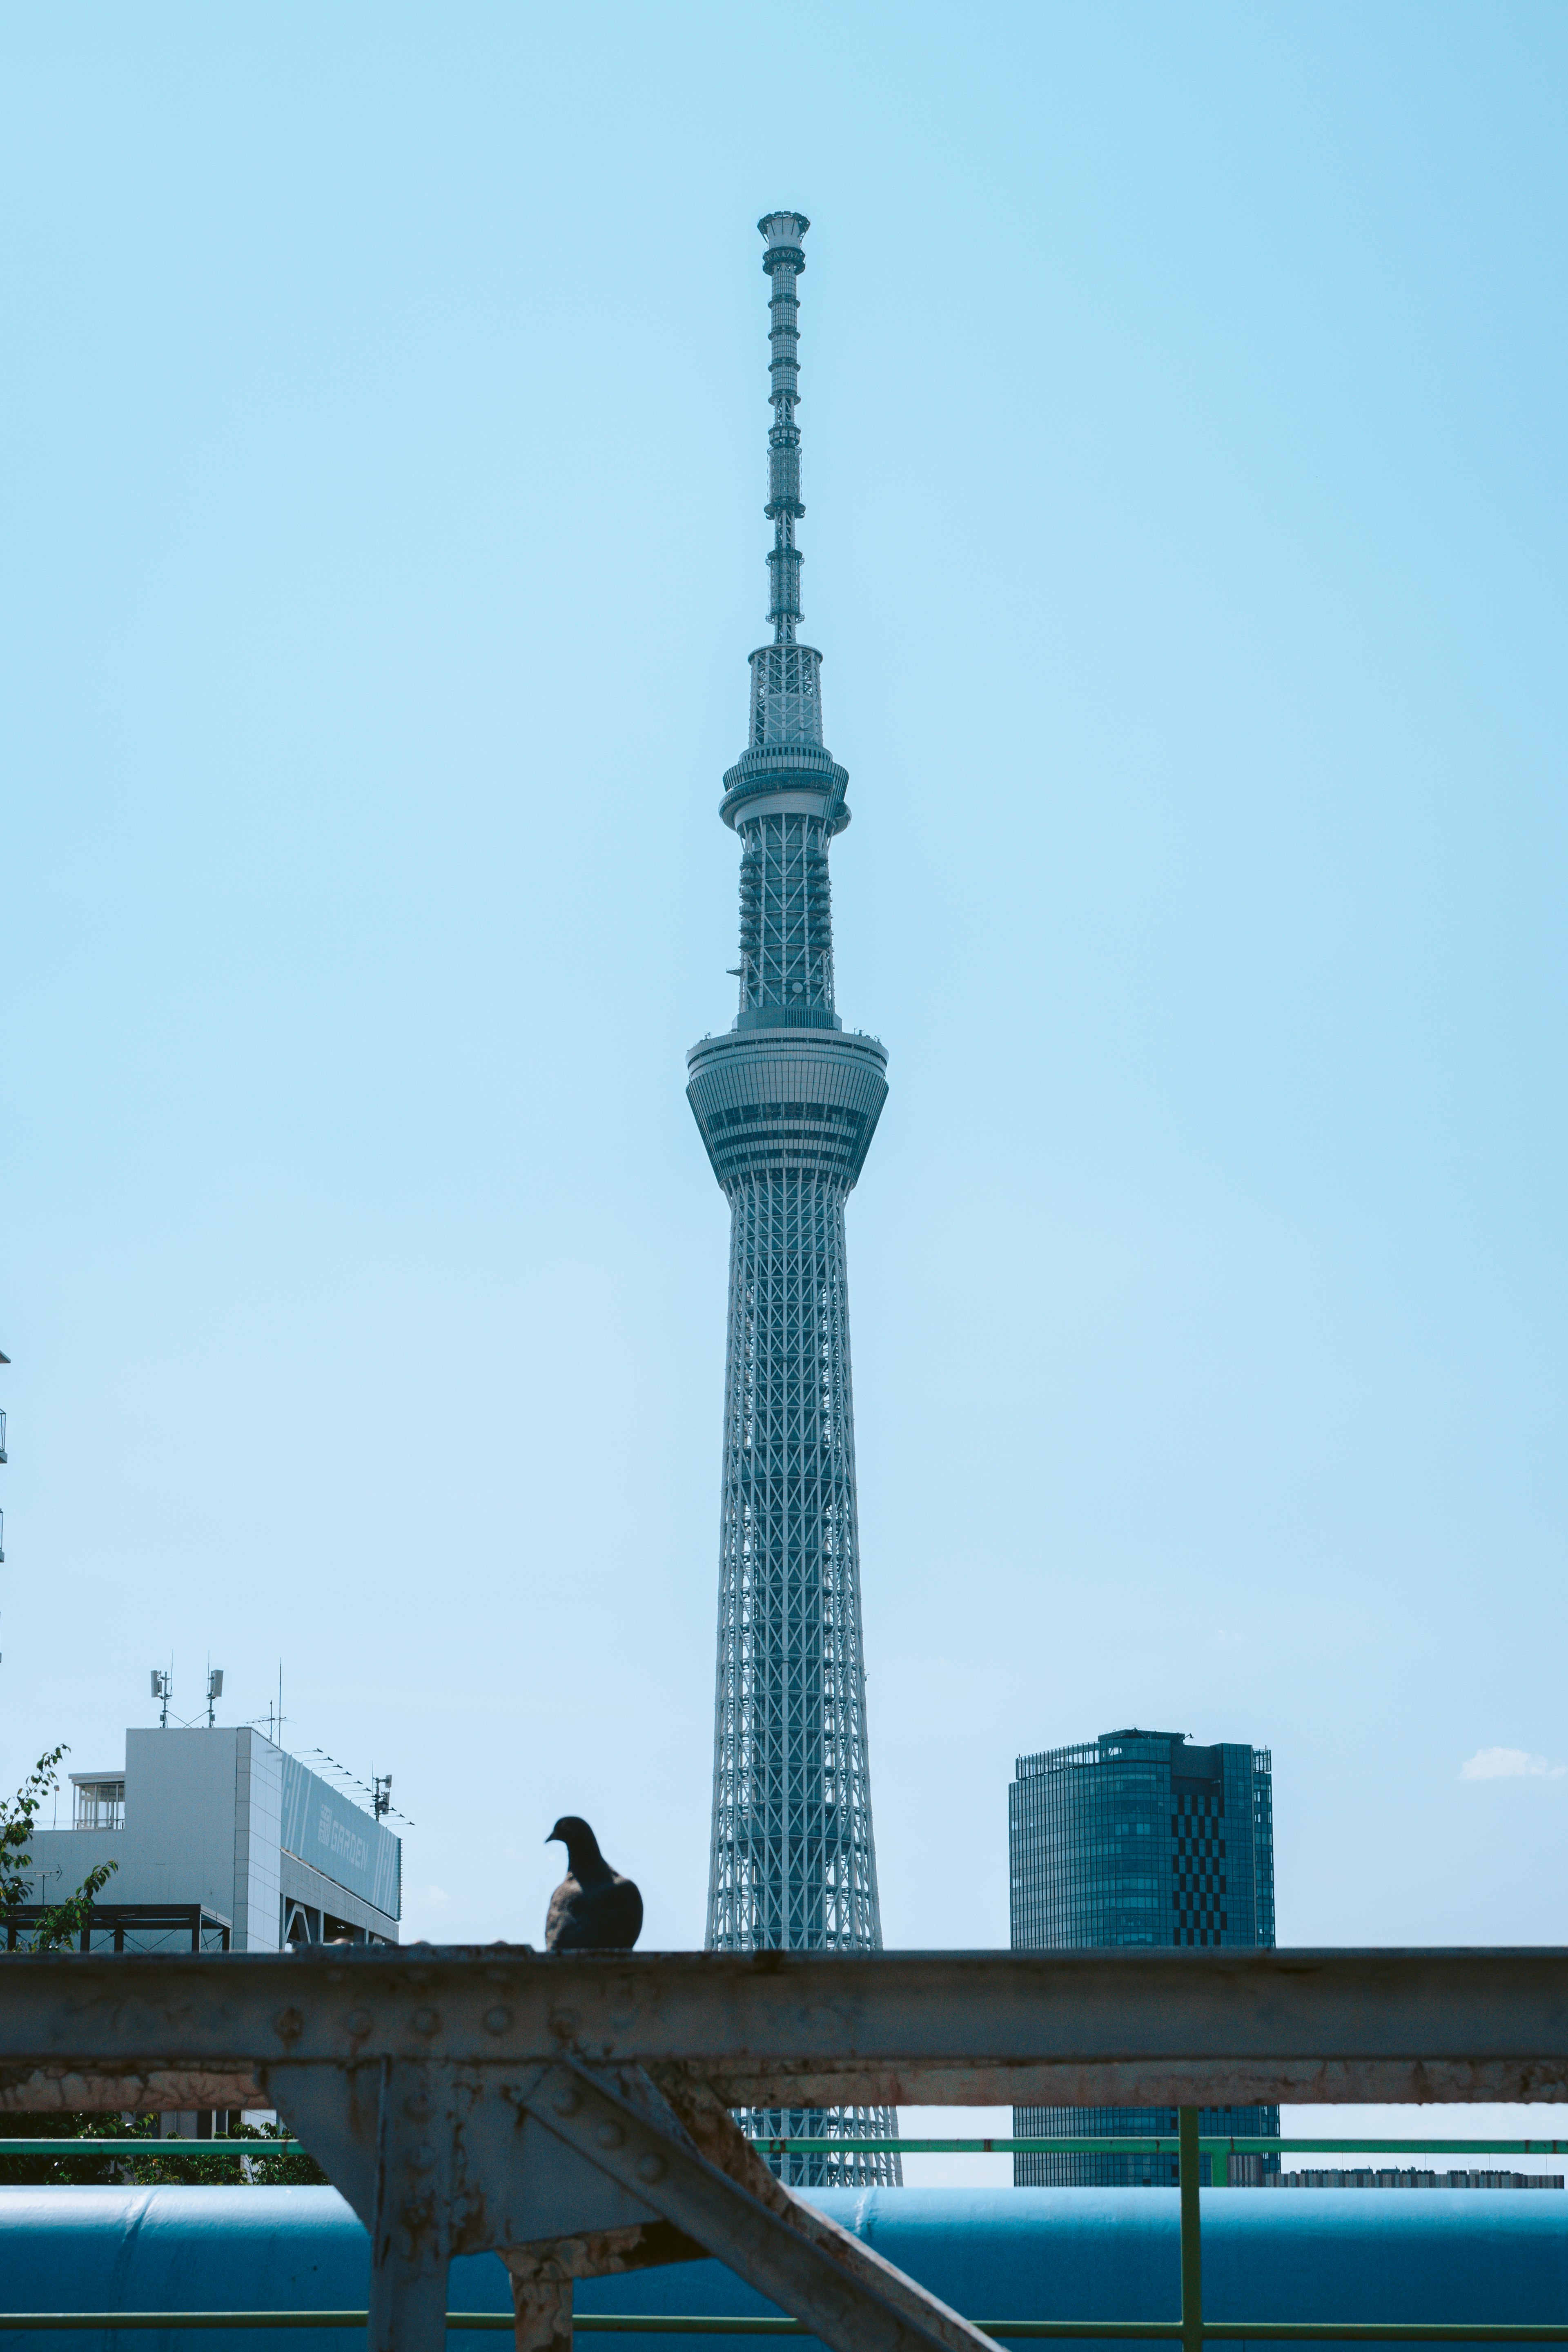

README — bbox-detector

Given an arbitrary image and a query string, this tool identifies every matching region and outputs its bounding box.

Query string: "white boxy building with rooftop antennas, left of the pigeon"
[12,1726,402,1952]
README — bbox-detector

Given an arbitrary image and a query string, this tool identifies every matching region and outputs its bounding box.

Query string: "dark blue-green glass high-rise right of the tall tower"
[1006,1731,1279,2187]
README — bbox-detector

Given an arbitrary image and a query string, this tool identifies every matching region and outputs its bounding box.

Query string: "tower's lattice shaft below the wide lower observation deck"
[708,1169,900,2185]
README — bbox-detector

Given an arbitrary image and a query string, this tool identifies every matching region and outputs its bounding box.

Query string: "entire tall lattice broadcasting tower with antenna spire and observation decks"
[686,212,898,2183]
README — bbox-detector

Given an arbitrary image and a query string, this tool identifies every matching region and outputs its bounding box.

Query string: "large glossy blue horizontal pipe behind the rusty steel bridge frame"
[0,2187,1568,2352]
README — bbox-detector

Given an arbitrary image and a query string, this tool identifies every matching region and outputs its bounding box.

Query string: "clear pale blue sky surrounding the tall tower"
[0,0,1568,2164]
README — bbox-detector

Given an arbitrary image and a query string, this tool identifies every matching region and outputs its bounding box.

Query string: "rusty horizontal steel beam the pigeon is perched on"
[0,1945,1568,2110]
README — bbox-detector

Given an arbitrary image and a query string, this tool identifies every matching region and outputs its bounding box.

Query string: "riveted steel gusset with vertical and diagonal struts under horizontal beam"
[268,2058,985,2352]
